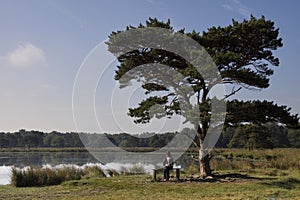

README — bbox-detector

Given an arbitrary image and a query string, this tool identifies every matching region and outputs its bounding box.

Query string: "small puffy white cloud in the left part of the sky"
[6,43,46,67]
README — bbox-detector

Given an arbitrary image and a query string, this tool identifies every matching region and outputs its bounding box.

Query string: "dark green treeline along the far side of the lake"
[0,124,300,149]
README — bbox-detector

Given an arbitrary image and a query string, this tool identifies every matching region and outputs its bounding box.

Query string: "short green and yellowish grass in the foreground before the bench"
[0,169,300,200]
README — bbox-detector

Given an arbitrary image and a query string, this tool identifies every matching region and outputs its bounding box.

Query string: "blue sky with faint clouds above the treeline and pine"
[0,0,300,132]
